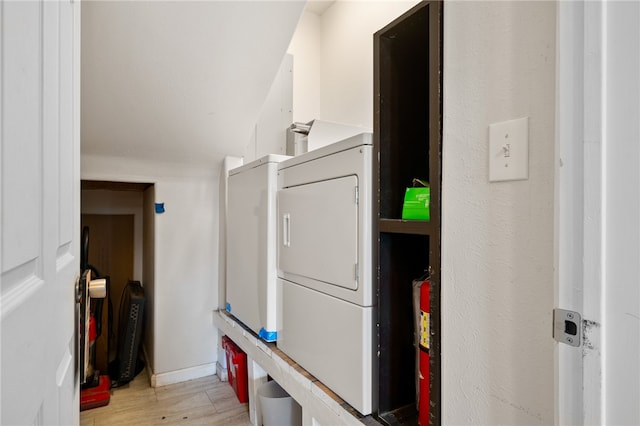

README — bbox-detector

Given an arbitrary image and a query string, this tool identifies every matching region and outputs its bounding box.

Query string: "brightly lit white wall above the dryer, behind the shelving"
[288,0,418,129]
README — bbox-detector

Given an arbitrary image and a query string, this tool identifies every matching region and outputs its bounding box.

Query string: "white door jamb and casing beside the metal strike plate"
[556,2,640,425]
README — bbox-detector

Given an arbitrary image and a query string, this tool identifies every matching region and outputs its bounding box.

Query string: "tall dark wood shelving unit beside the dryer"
[373,1,443,426]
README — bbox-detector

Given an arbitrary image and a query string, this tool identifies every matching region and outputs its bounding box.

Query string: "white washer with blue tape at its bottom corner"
[226,155,290,342]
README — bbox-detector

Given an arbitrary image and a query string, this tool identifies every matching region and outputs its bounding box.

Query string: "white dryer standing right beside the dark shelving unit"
[277,133,376,415]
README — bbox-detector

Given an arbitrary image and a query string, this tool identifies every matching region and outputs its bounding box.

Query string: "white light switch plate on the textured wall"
[489,117,529,182]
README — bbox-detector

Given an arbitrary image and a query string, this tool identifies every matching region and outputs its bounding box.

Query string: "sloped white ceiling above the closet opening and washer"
[81,0,308,164]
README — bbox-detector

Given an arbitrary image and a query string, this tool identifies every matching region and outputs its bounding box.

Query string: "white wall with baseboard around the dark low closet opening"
[82,155,220,386]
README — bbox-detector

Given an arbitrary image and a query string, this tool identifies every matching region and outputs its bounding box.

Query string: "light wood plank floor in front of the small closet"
[80,371,251,426]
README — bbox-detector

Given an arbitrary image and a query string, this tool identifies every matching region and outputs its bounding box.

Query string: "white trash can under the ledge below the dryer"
[258,380,302,426]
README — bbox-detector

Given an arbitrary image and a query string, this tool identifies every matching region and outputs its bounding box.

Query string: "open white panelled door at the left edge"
[0,1,80,425]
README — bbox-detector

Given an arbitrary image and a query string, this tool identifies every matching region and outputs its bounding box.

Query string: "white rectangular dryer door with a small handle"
[278,176,358,290]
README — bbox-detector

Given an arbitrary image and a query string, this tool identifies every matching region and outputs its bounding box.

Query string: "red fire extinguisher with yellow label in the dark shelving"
[418,281,430,426]
